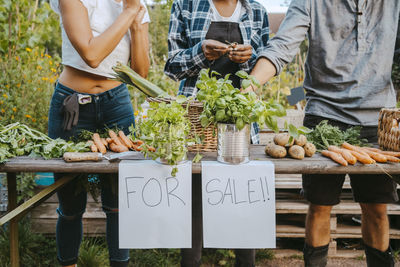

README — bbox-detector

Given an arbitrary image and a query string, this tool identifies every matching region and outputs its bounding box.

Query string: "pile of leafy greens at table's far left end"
[0,122,89,163]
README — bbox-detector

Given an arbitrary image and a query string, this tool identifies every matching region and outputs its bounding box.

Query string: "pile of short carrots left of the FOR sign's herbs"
[88,130,154,154]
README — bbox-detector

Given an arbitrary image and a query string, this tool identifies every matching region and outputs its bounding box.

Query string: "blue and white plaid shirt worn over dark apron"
[164,0,269,144]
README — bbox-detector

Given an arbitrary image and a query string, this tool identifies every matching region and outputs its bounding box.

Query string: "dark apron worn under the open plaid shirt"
[206,21,243,88]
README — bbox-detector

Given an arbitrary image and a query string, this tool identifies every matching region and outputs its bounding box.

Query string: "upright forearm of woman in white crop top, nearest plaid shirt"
[131,24,150,77]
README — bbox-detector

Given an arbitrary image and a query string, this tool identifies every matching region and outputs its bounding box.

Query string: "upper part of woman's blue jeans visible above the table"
[49,82,135,140]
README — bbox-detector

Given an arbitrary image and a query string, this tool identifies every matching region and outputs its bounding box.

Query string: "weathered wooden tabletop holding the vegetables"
[0,145,400,174]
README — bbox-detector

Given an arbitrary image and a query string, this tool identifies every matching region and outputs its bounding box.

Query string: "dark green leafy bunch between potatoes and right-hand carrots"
[306,120,368,151]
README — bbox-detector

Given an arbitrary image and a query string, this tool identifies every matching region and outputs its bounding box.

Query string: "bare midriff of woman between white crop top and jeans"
[58,66,121,94]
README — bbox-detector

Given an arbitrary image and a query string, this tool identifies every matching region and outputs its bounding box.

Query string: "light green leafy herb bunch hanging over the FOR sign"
[130,96,194,176]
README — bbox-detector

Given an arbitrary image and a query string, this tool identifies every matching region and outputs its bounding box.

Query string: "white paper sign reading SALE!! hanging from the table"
[202,161,276,248]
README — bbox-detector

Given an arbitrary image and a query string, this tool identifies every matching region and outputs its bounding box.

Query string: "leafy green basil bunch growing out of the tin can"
[196,69,286,132]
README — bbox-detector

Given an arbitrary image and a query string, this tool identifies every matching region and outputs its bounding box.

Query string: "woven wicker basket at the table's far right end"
[378,108,400,151]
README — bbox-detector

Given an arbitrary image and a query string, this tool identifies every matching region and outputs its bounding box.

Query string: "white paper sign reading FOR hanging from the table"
[119,160,192,249]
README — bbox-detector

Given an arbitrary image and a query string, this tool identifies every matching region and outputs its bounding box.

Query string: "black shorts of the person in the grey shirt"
[303,115,399,206]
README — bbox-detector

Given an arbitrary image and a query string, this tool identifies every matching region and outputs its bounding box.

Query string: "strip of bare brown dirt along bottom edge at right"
[256,258,400,267]
